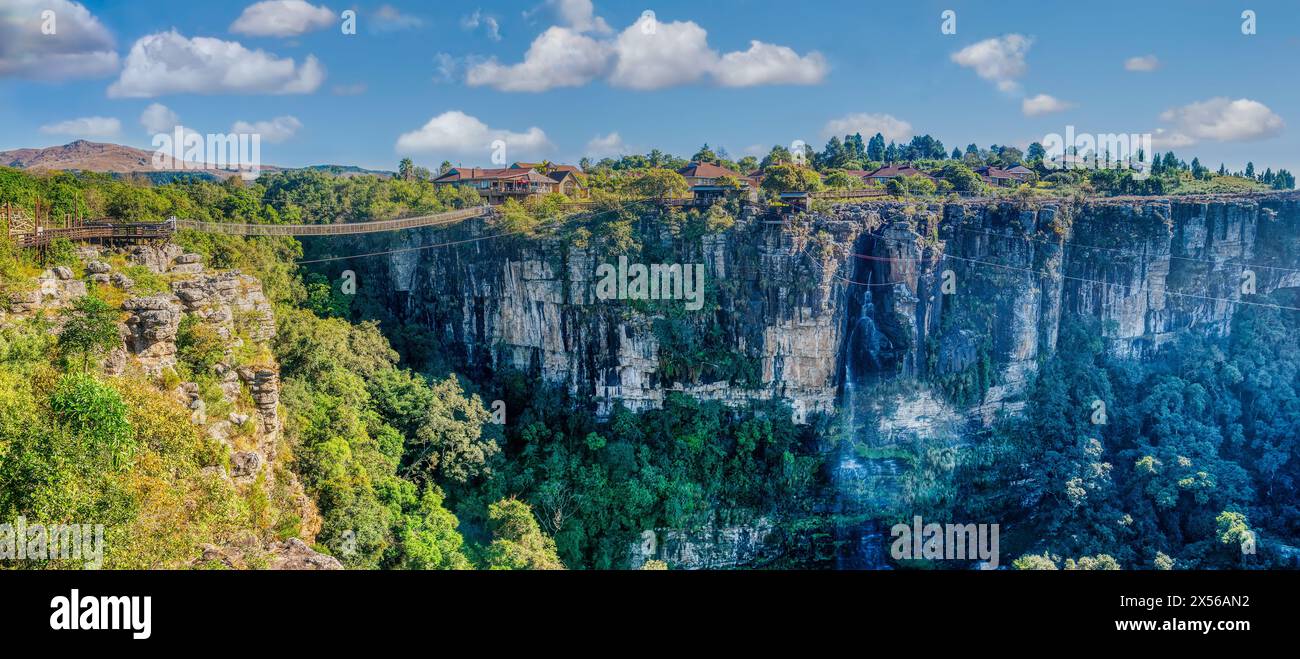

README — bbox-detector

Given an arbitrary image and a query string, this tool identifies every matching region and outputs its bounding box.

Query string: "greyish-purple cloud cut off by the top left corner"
[0,0,118,81]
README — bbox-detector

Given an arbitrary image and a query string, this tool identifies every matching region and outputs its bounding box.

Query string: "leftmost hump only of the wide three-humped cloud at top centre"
[465,27,610,91]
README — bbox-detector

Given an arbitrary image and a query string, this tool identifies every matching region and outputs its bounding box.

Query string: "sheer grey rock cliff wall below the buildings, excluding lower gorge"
[363,194,1300,432]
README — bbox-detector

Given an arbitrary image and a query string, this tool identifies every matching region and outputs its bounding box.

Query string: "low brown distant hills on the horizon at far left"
[0,139,393,181]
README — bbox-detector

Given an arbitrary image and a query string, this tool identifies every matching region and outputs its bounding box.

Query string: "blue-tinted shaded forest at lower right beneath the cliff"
[954,306,1300,569]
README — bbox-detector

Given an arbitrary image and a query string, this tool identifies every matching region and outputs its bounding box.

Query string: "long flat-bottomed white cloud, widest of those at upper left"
[108,30,325,97]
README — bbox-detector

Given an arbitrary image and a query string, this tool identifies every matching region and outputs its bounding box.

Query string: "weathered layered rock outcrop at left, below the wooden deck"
[0,243,342,569]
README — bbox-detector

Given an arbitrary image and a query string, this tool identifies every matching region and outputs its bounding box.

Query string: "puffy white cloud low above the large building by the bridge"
[397,110,551,160]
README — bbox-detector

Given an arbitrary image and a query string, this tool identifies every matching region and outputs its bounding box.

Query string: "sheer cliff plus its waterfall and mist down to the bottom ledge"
[308,194,1300,567]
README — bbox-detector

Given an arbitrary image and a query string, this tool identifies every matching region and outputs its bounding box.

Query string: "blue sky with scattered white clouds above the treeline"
[0,0,1300,170]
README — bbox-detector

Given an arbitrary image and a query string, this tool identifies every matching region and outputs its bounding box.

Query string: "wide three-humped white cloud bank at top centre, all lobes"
[465,14,829,91]
